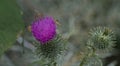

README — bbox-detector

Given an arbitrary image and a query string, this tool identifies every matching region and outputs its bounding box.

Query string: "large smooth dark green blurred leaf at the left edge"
[0,0,24,55]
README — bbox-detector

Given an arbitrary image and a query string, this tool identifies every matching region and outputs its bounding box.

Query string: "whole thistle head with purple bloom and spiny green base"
[31,16,65,60]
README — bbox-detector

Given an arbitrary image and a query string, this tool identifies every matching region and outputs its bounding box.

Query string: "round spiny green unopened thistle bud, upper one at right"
[88,27,115,51]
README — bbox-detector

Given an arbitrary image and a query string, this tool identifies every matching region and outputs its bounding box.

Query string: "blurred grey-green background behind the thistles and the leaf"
[0,0,120,66]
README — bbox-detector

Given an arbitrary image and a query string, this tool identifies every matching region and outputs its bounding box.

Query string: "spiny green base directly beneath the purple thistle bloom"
[36,35,65,60]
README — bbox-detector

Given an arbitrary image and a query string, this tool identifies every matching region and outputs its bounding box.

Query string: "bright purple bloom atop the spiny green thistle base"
[31,16,56,44]
